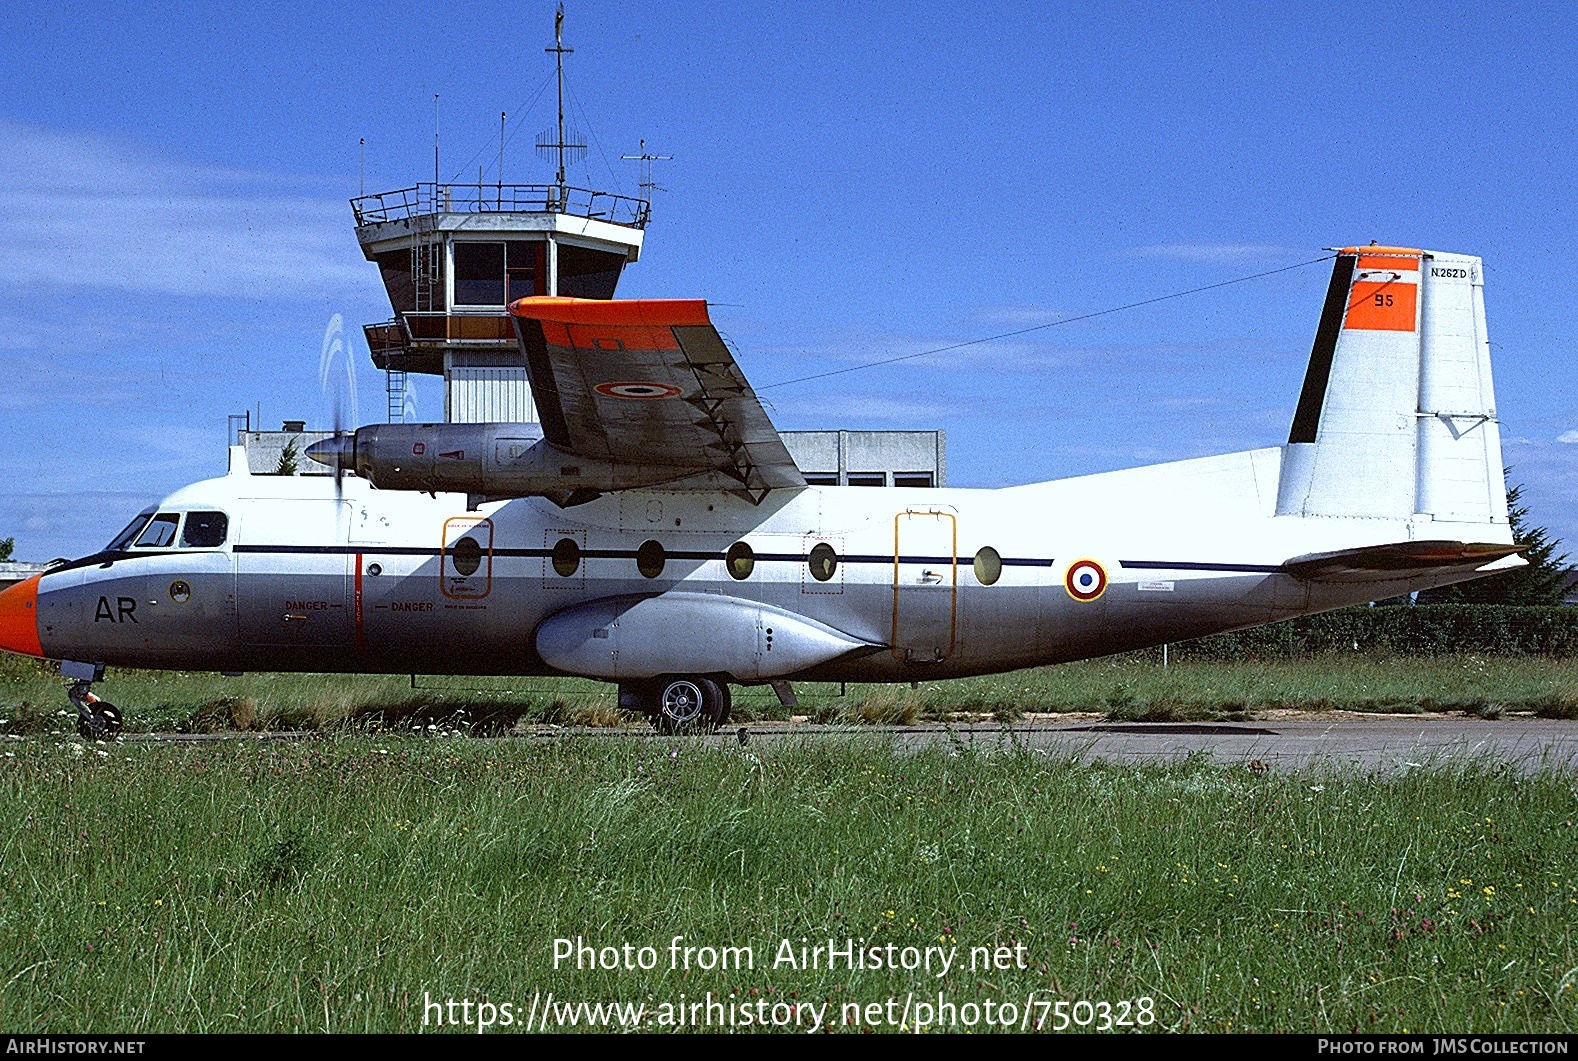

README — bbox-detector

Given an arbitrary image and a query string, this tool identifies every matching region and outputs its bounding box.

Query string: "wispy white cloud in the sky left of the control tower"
[0,120,377,302]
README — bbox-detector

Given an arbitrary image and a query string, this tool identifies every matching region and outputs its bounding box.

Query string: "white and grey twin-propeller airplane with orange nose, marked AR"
[0,245,1524,739]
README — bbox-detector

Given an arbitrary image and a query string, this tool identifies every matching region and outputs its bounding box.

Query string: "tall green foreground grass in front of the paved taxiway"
[0,734,1578,1033]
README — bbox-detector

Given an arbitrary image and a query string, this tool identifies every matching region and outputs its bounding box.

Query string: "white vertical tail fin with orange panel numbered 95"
[1277,246,1510,530]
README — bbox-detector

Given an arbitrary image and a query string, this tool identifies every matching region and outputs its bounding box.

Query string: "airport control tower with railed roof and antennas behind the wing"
[350,9,652,423]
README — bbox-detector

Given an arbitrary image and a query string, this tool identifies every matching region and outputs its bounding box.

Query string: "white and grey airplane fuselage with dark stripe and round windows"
[27,447,1485,682]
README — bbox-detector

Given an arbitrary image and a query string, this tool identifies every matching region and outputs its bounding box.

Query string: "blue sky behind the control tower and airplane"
[0,0,1578,560]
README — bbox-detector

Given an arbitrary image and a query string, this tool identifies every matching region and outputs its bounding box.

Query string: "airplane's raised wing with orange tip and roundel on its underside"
[510,297,805,501]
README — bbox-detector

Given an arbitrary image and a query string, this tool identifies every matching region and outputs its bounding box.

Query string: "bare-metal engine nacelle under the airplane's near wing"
[306,423,696,501]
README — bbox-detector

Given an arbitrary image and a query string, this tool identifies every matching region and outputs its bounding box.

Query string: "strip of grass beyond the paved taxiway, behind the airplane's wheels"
[0,654,1578,734]
